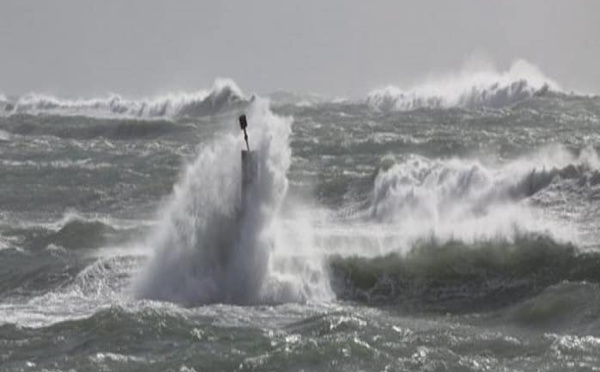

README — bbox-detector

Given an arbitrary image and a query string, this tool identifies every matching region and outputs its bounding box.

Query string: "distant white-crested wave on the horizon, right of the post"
[367,60,561,112]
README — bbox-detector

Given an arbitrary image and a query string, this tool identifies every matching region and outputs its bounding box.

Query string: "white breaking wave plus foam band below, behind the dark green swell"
[318,145,600,256]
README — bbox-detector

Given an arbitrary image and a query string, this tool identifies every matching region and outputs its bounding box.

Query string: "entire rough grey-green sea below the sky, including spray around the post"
[0,62,600,371]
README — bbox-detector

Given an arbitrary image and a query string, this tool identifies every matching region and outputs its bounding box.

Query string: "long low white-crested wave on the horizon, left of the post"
[7,79,249,118]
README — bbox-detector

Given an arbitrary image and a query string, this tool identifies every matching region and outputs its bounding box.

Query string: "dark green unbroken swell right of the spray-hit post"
[330,235,600,312]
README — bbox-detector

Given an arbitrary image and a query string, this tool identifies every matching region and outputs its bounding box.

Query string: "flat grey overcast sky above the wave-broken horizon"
[0,0,600,96]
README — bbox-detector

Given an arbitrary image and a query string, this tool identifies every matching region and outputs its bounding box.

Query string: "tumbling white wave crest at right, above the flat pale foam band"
[368,146,600,241]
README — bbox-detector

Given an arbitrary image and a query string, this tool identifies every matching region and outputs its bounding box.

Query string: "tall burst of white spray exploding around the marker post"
[134,100,331,305]
